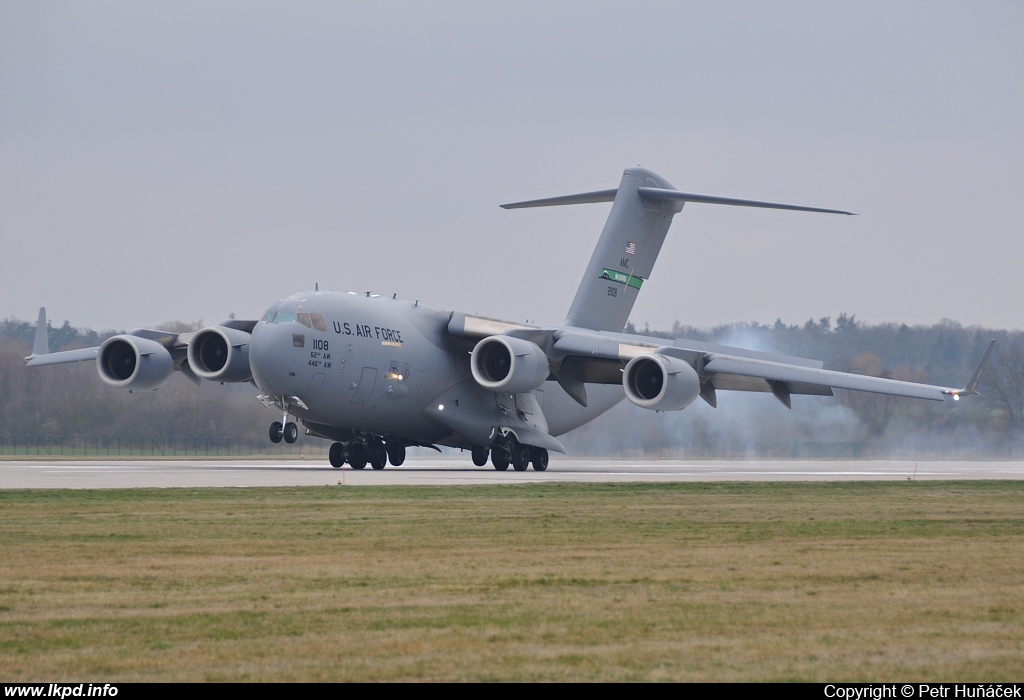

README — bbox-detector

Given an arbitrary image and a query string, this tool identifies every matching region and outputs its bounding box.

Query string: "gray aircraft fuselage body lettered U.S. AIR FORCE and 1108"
[249,291,624,447]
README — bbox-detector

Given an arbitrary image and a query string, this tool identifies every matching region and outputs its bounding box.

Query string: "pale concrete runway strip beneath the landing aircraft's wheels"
[0,455,1024,489]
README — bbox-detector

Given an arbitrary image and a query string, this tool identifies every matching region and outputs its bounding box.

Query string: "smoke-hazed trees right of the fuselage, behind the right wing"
[564,313,1024,458]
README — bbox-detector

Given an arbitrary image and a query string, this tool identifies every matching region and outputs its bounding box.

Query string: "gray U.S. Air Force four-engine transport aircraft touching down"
[27,167,992,471]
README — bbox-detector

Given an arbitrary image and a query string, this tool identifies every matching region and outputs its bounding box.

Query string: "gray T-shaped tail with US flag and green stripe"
[502,167,851,332]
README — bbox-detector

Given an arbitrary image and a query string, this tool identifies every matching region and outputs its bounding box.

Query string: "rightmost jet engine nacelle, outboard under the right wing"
[623,353,700,410]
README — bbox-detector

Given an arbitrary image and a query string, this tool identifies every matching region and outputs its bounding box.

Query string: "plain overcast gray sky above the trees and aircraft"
[0,0,1024,329]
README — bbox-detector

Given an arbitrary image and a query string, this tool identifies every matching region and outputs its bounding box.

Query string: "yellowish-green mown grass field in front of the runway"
[0,481,1024,682]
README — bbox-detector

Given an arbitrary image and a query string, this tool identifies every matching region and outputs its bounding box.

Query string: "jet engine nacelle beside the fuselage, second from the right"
[469,336,549,394]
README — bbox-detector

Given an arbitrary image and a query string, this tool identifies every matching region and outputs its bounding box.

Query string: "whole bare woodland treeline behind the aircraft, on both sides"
[0,314,1024,458]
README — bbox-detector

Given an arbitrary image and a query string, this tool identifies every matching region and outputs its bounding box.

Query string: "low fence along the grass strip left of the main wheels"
[0,435,331,460]
